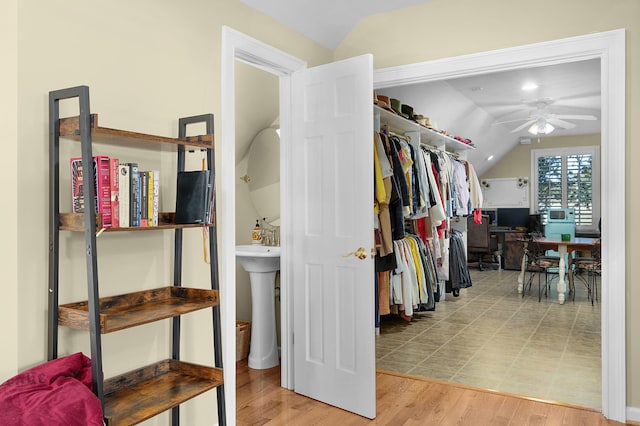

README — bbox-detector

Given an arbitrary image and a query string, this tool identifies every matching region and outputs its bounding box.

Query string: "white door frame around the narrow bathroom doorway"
[221,26,307,424]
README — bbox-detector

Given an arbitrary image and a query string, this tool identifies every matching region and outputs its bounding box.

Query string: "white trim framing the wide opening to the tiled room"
[373,29,627,422]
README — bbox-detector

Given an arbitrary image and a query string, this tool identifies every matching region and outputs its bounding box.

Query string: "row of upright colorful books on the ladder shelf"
[70,155,160,228]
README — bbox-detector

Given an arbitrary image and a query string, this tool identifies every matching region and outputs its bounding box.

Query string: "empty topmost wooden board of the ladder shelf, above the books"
[59,114,214,149]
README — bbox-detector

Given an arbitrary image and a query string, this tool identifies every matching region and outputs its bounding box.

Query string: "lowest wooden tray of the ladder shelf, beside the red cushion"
[104,359,223,426]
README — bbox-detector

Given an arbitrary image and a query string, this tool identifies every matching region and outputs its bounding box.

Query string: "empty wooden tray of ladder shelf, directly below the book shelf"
[58,286,219,334]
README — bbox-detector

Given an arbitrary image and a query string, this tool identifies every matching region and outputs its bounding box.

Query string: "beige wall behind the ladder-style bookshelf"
[11,0,332,424]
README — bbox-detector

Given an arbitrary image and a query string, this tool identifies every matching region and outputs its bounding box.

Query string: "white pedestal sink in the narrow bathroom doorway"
[236,245,280,369]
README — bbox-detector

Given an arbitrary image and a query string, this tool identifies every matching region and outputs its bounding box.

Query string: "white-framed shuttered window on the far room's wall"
[531,146,600,231]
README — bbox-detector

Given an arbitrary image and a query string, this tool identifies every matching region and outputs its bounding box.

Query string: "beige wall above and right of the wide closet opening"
[335,0,640,407]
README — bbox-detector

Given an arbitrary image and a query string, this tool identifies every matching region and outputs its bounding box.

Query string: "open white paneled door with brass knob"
[290,55,376,418]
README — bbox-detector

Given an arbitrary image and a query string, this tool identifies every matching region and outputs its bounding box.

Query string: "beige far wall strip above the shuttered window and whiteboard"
[480,134,600,179]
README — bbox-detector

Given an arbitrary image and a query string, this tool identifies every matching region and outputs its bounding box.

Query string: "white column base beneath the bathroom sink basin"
[249,272,279,369]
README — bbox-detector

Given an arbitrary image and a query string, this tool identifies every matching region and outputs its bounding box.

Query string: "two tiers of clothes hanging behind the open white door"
[374,128,483,321]
